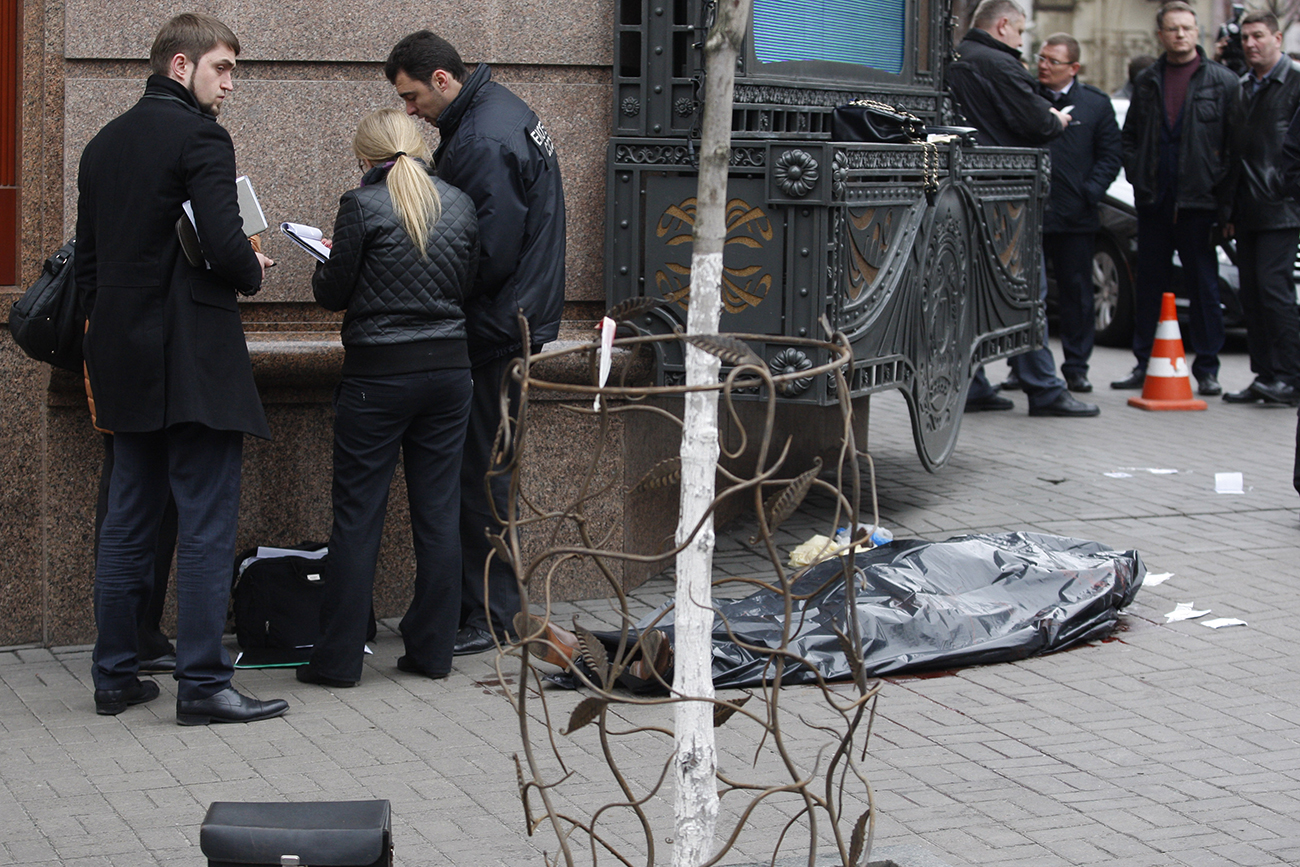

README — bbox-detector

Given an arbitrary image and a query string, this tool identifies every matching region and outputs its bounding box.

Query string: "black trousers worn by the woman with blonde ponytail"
[311,368,471,681]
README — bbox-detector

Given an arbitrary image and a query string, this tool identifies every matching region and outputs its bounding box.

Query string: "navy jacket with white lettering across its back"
[433,64,564,365]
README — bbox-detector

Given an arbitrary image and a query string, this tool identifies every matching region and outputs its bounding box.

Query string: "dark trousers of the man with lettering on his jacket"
[460,352,521,636]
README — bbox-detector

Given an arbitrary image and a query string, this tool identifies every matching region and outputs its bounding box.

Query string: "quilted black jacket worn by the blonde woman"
[312,162,478,376]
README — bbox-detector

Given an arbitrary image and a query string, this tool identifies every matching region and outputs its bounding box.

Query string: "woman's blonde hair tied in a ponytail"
[352,108,442,259]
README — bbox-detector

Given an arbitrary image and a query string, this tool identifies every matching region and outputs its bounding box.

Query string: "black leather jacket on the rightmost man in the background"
[1232,57,1300,231]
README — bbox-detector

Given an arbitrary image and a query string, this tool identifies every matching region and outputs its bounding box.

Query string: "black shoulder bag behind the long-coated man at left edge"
[9,238,86,373]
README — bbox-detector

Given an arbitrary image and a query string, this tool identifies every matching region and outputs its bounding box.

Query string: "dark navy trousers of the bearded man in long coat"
[91,422,243,701]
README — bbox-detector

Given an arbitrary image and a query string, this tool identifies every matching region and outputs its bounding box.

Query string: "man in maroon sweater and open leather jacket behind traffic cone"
[1110,0,1242,396]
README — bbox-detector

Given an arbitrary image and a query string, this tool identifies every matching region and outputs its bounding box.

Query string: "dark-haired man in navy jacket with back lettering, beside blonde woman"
[384,30,566,655]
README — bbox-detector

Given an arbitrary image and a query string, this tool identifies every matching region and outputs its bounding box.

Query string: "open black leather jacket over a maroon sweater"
[1121,45,1242,218]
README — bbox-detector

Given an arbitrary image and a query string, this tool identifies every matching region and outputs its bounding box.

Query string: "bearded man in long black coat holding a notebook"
[75,13,289,725]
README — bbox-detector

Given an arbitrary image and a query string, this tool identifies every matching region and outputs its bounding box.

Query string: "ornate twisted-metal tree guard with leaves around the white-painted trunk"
[491,317,880,867]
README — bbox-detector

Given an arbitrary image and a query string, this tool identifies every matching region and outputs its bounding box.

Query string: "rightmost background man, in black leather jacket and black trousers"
[1223,12,1300,407]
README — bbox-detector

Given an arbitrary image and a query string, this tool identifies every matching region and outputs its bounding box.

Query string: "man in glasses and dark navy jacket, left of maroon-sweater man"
[1039,32,1123,393]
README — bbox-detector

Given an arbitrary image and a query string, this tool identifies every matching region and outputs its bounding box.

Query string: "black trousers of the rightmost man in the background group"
[1236,229,1300,387]
